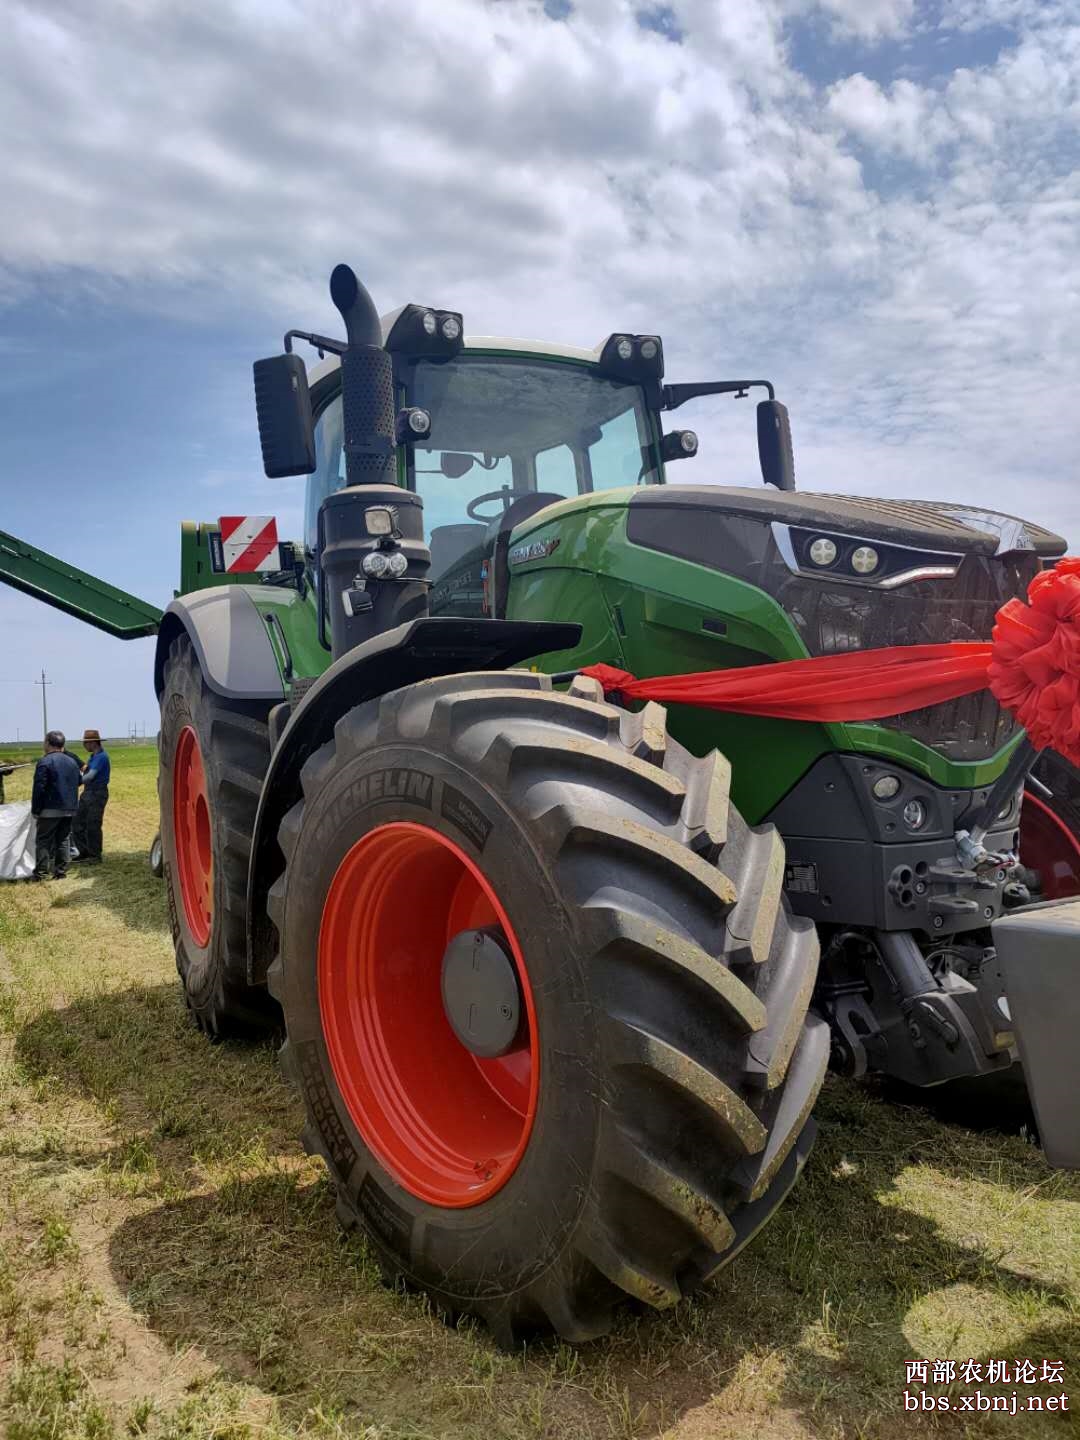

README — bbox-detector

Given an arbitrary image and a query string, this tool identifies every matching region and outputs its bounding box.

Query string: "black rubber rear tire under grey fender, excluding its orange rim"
[157,635,281,1040]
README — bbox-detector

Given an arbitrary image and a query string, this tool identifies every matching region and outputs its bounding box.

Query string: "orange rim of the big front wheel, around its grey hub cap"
[318,821,540,1208]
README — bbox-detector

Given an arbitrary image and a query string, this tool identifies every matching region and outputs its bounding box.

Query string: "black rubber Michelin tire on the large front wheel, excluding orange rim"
[269,671,828,1345]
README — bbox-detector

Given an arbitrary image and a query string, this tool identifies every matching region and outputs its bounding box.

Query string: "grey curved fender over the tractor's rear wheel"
[154,585,285,701]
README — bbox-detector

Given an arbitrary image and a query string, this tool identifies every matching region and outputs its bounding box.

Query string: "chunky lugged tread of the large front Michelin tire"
[268,671,828,1344]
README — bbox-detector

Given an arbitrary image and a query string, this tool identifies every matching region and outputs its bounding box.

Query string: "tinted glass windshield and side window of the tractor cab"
[300,354,662,570]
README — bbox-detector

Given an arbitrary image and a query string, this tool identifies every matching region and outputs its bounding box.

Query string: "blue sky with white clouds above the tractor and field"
[0,0,1080,739]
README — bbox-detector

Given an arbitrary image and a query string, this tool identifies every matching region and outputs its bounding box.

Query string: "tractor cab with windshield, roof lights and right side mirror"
[302,305,793,616]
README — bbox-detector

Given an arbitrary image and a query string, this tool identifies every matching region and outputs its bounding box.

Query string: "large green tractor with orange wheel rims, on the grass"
[0,266,1080,1344]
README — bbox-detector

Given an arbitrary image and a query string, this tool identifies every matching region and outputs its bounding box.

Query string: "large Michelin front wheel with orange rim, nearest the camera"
[269,671,828,1345]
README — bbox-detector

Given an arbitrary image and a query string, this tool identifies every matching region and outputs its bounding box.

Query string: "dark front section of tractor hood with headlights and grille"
[616,485,1066,760]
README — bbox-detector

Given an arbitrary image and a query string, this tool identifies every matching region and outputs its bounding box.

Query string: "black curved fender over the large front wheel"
[244,606,582,985]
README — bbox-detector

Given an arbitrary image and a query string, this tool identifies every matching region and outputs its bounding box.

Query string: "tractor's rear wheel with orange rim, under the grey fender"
[157,635,281,1040]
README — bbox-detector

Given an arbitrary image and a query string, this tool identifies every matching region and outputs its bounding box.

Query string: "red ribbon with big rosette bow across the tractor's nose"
[582,559,1080,765]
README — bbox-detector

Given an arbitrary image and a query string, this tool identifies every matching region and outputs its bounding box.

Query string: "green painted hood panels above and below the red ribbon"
[507,490,1017,824]
